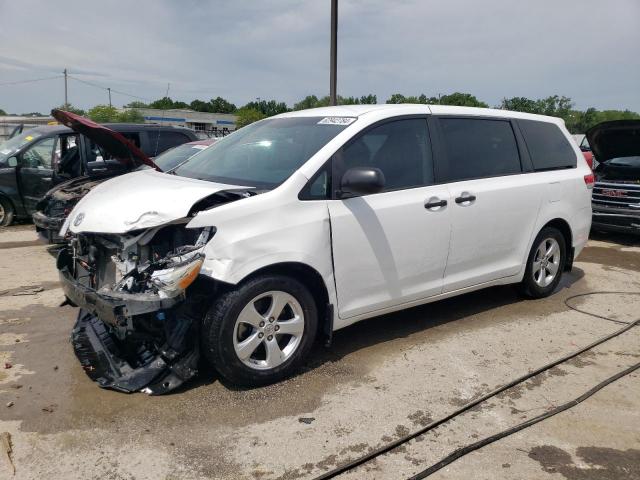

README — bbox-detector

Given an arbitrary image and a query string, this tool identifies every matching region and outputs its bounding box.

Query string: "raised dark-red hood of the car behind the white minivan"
[51,109,161,171]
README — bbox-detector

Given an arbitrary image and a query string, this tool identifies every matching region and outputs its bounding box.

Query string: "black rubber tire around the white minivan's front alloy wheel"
[201,275,318,387]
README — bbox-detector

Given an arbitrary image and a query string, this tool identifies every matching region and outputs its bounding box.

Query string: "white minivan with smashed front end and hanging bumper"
[57,105,593,394]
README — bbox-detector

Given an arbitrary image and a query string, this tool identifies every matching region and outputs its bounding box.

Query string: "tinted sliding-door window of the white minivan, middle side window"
[440,118,522,182]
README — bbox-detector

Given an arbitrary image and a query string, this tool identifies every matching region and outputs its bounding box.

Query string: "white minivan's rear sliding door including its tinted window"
[437,117,544,292]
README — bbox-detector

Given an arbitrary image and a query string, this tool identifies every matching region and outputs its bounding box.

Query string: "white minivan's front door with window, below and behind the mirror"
[328,117,450,318]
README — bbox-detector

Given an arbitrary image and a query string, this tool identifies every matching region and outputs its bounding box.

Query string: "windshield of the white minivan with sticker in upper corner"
[174,117,355,188]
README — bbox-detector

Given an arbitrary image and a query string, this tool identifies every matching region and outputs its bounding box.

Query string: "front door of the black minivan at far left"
[18,136,57,215]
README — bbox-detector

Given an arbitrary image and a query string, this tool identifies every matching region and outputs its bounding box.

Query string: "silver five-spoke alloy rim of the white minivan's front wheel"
[233,290,305,370]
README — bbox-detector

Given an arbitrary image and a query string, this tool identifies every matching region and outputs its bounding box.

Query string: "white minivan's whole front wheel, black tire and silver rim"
[201,275,318,387]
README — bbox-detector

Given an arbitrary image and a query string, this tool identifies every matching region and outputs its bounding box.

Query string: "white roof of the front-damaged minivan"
[277,103,563,123]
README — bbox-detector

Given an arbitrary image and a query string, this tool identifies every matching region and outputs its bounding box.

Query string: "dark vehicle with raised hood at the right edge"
[586,120,640,233]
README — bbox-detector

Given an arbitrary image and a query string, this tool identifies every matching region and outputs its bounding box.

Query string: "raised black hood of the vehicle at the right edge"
[586,120,640,162]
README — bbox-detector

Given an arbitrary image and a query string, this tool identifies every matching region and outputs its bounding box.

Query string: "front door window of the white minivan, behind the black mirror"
[334,118,433,191]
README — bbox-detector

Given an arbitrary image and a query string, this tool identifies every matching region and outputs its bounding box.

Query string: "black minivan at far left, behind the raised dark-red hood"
[0,115,197,226]
